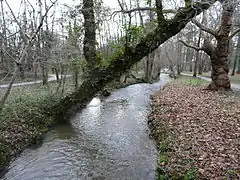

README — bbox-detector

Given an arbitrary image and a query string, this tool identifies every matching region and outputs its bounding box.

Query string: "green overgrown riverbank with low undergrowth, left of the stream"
[0,77,142,177]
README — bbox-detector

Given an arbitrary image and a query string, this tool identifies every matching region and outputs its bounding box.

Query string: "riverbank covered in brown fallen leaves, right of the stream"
[148,77,240,179]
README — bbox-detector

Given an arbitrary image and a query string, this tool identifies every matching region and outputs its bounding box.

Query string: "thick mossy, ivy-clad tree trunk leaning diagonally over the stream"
[51,0,214,119]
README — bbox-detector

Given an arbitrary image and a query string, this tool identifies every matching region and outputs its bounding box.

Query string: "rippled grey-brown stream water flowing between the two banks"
[3,75,169,180]
